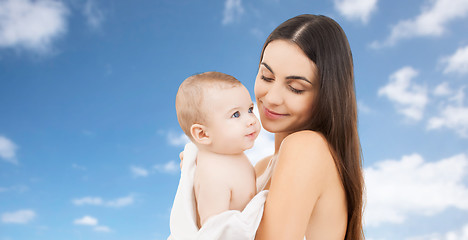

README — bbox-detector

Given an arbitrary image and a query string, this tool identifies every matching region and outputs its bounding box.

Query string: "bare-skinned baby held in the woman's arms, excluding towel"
[176,72,260,228]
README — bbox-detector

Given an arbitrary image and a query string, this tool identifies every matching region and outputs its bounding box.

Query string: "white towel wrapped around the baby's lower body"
[168,143,268,240]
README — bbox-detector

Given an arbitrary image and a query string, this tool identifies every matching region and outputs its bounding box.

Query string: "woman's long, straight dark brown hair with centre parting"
[260,14,364,240]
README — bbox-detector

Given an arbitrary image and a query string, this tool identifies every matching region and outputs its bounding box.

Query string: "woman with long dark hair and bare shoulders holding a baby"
[255,15,364,240]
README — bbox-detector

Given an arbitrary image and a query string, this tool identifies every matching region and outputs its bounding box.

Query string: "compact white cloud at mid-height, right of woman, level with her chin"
[378,67,428,121]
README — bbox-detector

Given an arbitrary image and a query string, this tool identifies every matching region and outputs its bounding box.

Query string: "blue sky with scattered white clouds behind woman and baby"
[0,0,468,240]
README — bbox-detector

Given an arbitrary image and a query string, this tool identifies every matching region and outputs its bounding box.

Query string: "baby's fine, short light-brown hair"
[176,72,242,140]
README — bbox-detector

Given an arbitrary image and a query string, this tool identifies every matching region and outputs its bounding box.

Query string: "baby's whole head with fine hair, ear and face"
[176,72,260,154]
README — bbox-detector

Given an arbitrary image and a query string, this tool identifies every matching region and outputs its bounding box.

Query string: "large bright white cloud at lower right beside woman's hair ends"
[365,154,468,226]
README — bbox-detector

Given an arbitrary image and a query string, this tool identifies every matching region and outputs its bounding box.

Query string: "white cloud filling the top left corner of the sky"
[0,0,68,53]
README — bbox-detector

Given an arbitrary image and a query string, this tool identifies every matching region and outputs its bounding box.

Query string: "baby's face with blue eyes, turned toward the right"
[203,85,260,154]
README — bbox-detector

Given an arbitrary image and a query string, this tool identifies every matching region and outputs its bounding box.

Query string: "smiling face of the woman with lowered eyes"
[255,40,319,133]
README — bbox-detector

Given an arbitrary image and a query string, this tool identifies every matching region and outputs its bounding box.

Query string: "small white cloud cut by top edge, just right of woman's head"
[334,0,378,23]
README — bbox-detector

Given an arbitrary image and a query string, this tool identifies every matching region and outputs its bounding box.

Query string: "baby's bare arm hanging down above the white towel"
[195,167,231,226]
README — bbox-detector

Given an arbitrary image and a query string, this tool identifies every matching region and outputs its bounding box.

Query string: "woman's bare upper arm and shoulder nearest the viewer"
[255,131,335,240]
